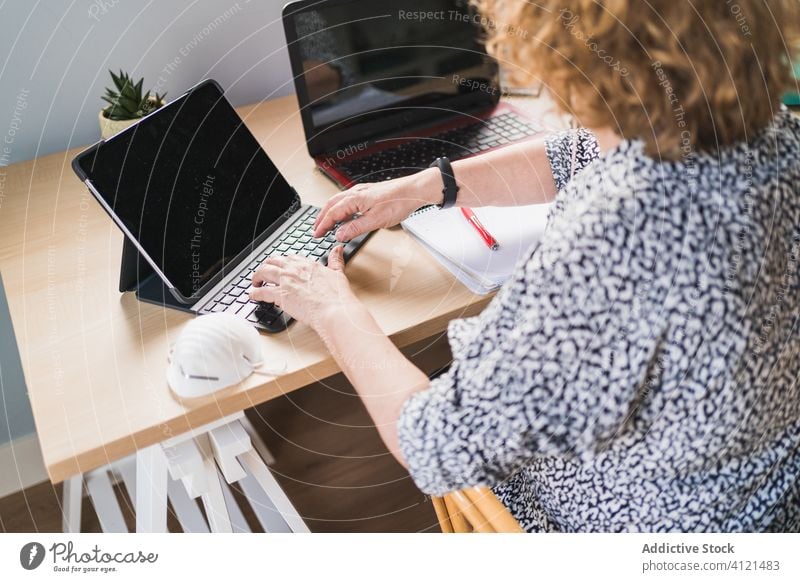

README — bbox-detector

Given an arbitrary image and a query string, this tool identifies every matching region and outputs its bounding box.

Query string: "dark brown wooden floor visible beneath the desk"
[0,337,450,532]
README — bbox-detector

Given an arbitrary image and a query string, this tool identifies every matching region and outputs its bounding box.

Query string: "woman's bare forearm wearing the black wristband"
[413,138,556,208]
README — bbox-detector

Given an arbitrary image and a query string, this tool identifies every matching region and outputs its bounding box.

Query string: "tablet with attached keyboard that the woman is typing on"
[72,80,364,332]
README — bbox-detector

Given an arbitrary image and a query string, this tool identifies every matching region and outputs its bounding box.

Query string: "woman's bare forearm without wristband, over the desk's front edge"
[316,301,429,466]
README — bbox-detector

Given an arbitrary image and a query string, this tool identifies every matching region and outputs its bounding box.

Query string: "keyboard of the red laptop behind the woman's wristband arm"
[338,112,539,183]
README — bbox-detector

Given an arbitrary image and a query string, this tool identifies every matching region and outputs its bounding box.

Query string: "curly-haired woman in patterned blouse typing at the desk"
[252,0,800,531]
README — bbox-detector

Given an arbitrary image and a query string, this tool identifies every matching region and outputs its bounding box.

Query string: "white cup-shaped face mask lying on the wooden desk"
[167,313,286,398]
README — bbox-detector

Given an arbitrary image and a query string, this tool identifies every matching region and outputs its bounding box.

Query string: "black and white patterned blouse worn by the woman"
[398,110,800,531]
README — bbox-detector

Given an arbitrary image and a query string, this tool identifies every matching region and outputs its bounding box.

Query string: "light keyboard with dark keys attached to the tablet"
[199,208,336,331]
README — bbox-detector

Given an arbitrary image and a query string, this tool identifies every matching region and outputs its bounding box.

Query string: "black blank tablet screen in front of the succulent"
[78,82,295,298]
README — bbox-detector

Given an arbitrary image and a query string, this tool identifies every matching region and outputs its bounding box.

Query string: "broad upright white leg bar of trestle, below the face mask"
[136,444,167,533]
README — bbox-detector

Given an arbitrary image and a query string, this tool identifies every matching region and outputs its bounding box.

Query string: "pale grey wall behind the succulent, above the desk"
[0,0,293,166]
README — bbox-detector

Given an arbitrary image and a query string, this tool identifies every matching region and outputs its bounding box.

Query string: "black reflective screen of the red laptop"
[284,0,500,154]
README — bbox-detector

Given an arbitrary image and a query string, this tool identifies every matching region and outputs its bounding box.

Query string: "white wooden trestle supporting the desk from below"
[63,412,309,533]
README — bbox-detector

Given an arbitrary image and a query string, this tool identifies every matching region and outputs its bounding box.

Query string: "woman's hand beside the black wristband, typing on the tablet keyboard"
[314,168,442,242]
